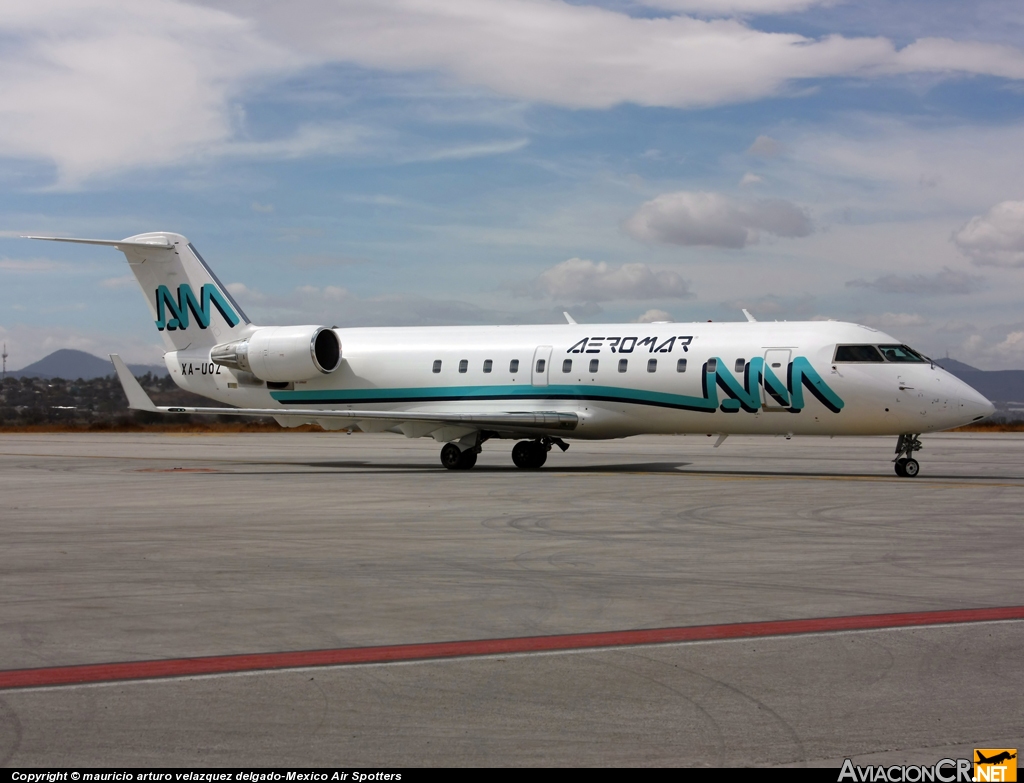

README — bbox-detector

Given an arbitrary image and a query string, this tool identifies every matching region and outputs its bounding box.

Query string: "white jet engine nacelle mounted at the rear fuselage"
[210,327,341,383]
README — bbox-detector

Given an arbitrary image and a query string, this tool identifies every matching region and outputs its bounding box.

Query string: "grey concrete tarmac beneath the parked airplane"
[0,432,1024,769]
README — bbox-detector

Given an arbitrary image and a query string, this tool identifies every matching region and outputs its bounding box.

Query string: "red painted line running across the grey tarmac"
[0,606,1024,690]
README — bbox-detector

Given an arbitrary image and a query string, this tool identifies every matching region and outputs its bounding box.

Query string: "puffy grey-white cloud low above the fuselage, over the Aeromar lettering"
[517,258,693,302]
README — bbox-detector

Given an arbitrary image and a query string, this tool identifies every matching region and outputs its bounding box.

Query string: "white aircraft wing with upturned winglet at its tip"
[111,353,580,434]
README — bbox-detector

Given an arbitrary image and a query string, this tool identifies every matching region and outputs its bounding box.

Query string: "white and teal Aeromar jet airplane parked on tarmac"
[26,231,994,478]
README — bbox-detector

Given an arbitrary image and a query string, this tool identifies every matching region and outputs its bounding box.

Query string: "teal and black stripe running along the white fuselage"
[270,384,718,412]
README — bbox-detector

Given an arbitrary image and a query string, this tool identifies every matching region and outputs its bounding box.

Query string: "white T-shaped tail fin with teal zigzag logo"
[26,231,251,351]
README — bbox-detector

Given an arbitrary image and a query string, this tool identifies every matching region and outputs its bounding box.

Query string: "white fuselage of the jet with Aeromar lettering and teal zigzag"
[166,321,993,439]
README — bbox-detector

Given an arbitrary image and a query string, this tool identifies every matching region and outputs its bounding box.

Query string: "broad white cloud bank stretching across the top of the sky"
[6,0,1024,187]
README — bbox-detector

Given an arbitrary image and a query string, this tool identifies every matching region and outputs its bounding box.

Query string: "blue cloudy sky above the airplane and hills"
[0,0,1024,369]
